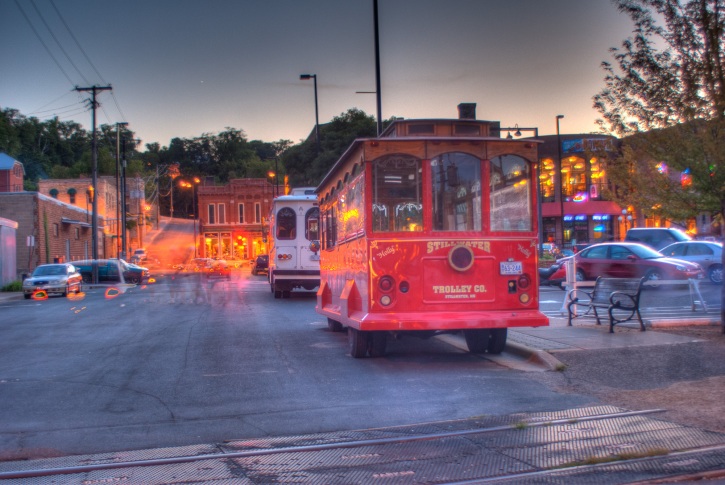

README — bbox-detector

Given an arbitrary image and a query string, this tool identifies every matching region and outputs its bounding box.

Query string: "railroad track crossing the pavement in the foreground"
[0,406,725,485]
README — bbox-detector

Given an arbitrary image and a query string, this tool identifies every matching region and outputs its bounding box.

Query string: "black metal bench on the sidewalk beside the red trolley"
[566,276,645,333]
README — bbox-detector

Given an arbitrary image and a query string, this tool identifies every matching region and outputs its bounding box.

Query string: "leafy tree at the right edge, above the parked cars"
[594,0,725,333]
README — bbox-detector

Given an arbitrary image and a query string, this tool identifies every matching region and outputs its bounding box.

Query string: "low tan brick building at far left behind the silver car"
[0,192,95,276]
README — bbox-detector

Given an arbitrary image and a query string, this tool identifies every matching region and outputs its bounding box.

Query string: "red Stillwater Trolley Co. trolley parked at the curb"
[315,112,549,357]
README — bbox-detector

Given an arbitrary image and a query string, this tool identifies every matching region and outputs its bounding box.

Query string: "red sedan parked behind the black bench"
[573,242,705,281]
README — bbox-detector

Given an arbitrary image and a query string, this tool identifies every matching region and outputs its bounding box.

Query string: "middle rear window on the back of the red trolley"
[431,153,482,231]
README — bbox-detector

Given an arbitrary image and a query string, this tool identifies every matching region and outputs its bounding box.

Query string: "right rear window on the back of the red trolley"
[490,155,533,232]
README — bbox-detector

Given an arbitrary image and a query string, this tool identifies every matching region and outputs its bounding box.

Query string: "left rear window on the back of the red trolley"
[372,155,423,232]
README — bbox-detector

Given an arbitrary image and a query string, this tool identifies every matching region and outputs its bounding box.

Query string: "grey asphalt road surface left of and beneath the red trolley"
[0,266,596,459]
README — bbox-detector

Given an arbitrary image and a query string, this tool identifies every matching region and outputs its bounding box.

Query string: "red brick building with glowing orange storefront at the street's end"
[196,178,275,260]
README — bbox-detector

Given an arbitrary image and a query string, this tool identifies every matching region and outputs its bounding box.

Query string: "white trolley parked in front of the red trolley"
[268,187,320,298]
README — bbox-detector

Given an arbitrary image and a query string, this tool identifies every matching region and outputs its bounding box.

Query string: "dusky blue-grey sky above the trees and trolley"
[0,0,632,146]
